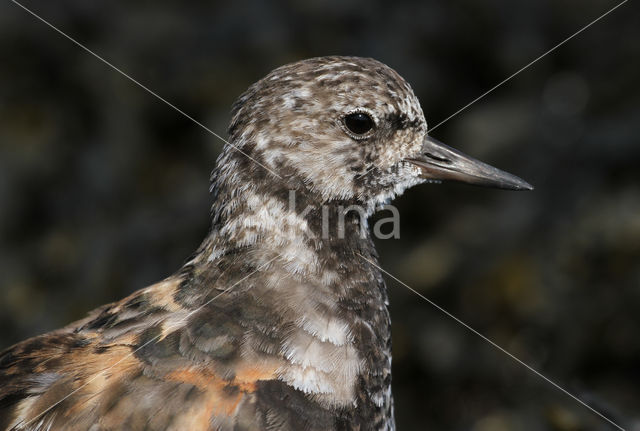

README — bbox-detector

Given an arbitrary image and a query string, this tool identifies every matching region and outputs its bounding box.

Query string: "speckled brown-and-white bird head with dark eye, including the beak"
[224,57,532,211]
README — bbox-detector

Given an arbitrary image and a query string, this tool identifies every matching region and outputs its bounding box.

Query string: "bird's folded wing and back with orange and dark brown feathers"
[0,277,277,431]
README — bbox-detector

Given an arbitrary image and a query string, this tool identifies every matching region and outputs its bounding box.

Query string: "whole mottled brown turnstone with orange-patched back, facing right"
[0,56,532,431]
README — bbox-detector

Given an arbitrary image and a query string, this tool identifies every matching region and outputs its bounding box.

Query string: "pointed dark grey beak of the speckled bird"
[406,136,533,190]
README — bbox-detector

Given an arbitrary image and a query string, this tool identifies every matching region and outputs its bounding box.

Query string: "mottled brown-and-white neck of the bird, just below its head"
[196,161,373,274]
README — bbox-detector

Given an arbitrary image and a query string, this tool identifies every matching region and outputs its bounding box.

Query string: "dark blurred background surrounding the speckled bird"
[0,0,640,431]
